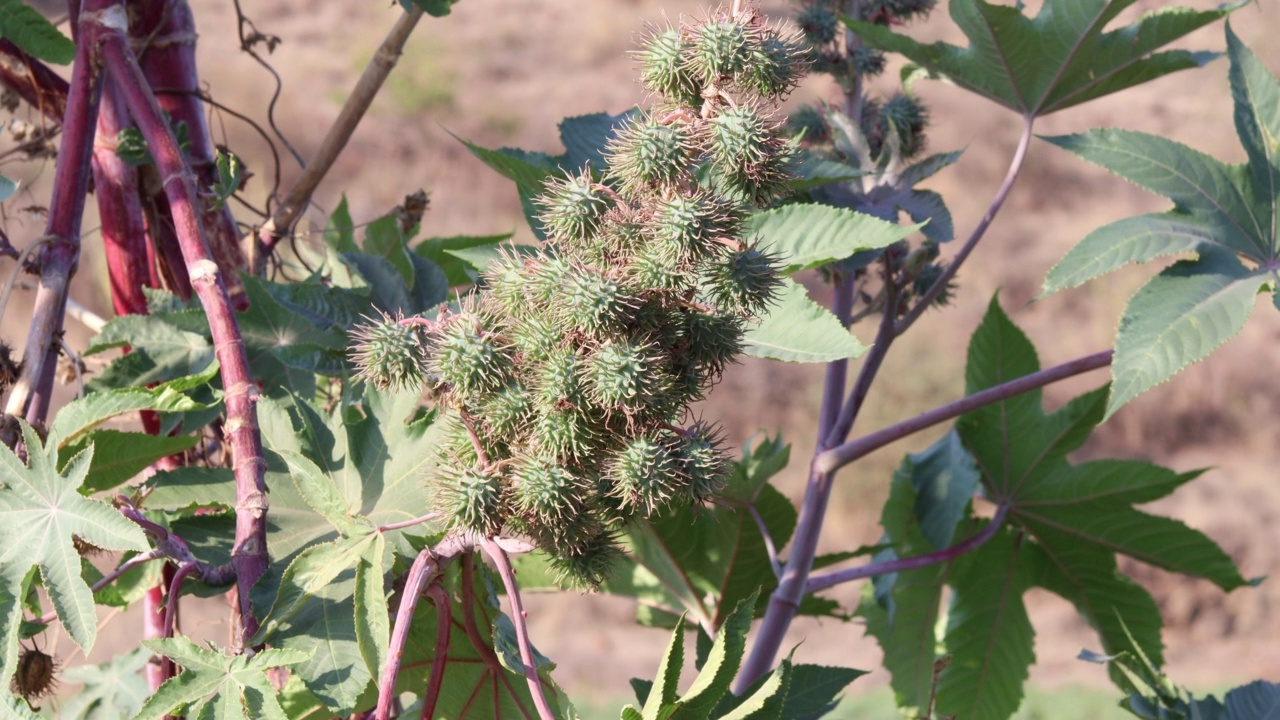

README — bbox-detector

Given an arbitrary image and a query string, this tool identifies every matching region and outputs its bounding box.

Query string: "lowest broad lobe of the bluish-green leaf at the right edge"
[1106,249,1268,418]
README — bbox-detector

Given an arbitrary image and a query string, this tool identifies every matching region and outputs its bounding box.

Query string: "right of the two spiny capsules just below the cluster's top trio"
[709,106,791,205]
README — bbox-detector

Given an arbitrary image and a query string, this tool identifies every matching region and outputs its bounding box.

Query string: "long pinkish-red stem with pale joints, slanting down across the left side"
[101,26,269,643]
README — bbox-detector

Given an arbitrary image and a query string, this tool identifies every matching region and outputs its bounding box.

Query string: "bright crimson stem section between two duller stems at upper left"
[93,79,151,315]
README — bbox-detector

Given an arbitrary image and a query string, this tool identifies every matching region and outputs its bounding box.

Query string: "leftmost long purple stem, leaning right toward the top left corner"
[5,3,102,425]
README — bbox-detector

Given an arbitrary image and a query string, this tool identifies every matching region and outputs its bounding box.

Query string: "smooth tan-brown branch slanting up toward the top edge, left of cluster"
[244,5,422,273]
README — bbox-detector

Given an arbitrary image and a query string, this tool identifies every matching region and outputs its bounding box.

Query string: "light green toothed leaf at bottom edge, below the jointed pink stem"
[134,638,307,720]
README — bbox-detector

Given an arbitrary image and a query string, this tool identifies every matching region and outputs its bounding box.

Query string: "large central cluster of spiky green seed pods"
[356,2,803,584]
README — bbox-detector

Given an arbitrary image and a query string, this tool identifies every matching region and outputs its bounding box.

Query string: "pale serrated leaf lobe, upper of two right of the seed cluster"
[742,204,920,274]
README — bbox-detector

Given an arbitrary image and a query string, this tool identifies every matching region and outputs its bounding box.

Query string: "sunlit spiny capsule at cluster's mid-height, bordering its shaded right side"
[586,341,671,414]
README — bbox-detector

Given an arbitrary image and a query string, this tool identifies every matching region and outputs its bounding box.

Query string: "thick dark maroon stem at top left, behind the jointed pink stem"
[129,0,247,309]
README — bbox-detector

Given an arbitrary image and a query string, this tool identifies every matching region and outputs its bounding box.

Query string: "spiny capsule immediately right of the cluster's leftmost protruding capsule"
[430,313,508,400]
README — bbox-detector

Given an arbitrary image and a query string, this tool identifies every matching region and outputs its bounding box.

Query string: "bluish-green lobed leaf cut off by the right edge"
[1044,26,1280,416]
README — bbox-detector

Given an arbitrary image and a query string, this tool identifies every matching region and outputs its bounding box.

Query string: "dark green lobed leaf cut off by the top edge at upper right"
[845,0,1244,117]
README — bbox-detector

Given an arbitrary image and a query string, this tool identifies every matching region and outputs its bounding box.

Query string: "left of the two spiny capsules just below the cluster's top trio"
[608,118,694,195]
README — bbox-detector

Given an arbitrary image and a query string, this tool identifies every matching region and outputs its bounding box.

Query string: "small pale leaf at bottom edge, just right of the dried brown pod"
[59,647,151,720]
